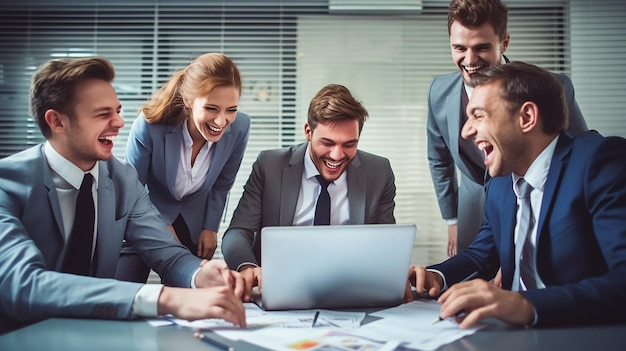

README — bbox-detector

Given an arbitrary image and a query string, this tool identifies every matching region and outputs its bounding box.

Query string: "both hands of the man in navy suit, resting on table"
[404,266,535,329]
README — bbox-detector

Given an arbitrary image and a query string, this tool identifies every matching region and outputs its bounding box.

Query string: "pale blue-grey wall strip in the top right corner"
[569,0,626,137]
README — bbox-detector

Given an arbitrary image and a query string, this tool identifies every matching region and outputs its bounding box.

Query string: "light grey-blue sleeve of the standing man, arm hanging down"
[426,78,459,219]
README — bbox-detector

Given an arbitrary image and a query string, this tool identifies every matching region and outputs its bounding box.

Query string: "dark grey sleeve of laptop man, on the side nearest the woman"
[222,152,265,269]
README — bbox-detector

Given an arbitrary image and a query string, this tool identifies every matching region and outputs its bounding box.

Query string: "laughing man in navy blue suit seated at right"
[411,62,626,327]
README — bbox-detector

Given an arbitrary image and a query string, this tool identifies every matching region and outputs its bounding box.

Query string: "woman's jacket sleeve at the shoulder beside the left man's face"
[126,113,152,184]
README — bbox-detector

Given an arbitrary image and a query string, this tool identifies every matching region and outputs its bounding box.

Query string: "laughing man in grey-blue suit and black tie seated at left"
[0,57,245,333]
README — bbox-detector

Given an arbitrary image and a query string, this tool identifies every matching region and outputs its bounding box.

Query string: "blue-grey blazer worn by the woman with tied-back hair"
[126,112,250,243]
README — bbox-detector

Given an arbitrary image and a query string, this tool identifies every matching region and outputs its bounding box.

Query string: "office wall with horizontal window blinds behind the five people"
[0,0,626,264]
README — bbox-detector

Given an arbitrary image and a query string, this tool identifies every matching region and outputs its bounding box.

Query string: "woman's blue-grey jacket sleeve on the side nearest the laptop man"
[203,112,250,232]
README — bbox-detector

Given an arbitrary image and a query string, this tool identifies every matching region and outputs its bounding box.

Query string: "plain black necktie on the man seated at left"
[62,173,95,275]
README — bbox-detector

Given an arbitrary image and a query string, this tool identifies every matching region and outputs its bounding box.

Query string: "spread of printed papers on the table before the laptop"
[147,300,486,351]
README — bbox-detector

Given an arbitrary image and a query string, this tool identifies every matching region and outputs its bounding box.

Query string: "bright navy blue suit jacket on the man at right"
[428,132,626,325]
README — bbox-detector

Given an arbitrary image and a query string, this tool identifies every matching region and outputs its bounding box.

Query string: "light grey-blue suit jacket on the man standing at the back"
[427,72,587,251]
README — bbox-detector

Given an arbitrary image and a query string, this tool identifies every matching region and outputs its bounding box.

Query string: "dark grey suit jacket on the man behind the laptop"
[222,143,396,269]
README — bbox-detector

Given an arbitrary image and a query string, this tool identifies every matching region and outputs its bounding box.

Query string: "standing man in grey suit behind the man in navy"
[427,0,587,256]
